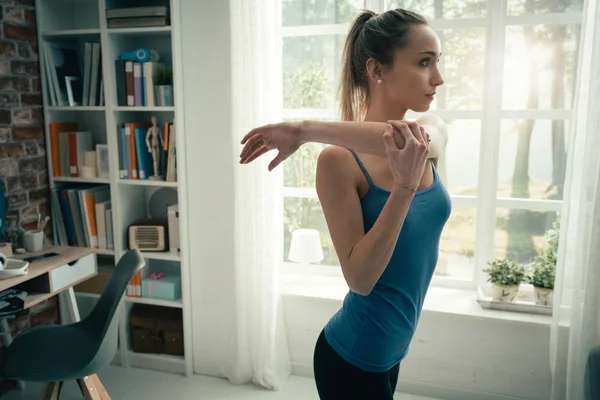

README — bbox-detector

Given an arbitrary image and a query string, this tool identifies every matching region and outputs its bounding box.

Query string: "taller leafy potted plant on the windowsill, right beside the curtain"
[528,219,560,306]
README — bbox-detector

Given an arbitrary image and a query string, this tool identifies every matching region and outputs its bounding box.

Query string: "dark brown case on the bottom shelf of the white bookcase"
[129,304,183,356]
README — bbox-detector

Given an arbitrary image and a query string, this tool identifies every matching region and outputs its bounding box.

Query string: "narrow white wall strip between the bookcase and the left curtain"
[181,0,234,375]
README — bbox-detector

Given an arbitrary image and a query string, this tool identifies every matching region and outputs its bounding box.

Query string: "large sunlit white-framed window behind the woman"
[283,0,583,288]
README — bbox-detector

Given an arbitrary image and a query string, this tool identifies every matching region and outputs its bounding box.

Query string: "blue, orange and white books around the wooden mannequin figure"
[117,121,177,182]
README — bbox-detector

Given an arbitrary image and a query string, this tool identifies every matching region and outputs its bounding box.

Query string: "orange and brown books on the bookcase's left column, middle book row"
[48,121,96,178]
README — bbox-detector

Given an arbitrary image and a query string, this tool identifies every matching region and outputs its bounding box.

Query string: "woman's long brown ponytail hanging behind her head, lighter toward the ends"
[338,10,377,121]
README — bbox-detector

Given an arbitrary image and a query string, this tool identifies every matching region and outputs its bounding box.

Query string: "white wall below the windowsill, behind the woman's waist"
[284,295,551,400]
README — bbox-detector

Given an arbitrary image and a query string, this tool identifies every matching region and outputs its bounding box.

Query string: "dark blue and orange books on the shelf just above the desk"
[51,185,114,250]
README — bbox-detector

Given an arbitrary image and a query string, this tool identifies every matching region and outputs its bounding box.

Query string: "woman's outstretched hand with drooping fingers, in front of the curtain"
[240,122,302,171]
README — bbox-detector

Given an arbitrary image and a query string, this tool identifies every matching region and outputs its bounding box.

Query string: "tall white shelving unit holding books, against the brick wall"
[36,0,192,376]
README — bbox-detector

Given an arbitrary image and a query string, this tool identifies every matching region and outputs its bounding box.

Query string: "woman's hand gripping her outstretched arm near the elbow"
[383,121,429,192]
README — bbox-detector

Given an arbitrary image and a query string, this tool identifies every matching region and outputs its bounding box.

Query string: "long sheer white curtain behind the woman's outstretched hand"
[224,0,290,390]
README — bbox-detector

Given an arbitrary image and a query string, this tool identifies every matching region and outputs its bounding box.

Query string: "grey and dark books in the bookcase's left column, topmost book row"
[40,41,104,107]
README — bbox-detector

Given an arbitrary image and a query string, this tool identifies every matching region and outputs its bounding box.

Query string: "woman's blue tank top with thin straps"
[325,151,451,372]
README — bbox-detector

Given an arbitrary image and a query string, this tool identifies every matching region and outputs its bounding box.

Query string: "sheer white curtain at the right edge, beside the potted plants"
[550,0,600,400]
